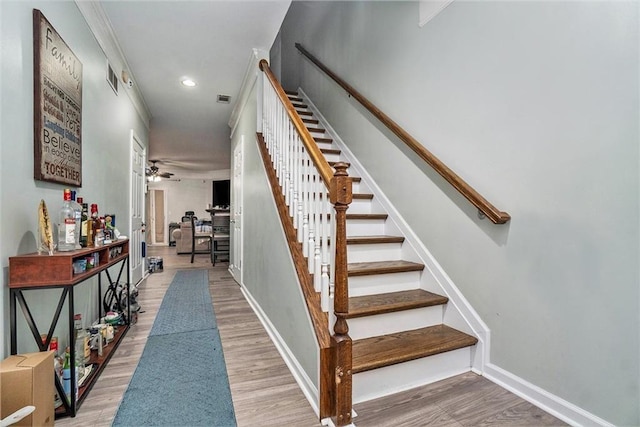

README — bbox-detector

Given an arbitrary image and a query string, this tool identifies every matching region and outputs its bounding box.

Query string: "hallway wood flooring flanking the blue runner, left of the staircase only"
[55,246,320,427]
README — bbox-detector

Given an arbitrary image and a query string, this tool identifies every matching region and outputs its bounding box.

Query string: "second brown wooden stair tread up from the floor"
[346,289,449,319]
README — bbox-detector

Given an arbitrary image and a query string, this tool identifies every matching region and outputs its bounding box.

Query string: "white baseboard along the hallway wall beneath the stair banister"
[240,283,320,417]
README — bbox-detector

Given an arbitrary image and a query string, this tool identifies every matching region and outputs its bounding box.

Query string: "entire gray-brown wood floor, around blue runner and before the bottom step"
[56,247,564,427]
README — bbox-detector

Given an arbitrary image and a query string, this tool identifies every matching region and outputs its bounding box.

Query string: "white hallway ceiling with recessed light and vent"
[100,0,291,178]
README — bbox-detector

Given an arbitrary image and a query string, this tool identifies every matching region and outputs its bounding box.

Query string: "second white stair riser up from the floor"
[347,305,444,340]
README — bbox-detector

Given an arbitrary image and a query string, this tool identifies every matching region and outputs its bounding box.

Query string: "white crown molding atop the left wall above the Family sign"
[75,0,151,129]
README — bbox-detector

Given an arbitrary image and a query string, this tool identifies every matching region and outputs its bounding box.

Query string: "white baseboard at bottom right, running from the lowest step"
[483,363,613,427]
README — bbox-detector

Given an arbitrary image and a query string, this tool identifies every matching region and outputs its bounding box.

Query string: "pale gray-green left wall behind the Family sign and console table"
[0,1,148,357]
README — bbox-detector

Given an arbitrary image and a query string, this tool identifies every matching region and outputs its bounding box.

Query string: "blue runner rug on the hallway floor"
[112,270,237,427]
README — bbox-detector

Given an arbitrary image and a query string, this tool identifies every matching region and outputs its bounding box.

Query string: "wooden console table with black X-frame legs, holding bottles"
[9,239,131,418]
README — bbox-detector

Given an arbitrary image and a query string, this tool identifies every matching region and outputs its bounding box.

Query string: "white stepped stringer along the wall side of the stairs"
[298,88,490,374]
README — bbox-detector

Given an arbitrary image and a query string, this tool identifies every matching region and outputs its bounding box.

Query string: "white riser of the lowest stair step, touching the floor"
[353,347,471,403]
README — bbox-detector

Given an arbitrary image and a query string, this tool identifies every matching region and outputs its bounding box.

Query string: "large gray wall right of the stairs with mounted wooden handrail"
[280,1,640,425]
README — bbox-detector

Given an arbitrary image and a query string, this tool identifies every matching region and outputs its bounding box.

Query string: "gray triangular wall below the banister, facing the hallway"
[231,81,319,388]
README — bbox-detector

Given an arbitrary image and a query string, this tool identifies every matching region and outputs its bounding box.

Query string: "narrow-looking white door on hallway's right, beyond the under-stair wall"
[229,139,244,283]
